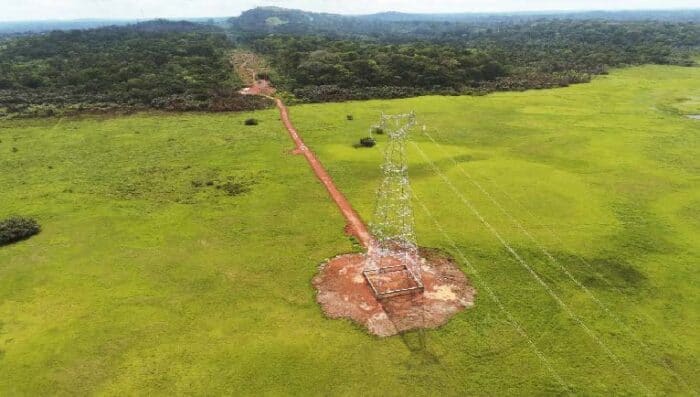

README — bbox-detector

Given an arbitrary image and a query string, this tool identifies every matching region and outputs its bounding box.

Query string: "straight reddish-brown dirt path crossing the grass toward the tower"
[275,98,372,248]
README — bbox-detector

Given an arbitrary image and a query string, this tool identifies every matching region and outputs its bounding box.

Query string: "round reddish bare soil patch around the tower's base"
[313,249,476,337]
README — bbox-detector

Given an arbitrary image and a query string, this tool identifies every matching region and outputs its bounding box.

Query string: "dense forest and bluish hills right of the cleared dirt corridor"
[232,8,700,101]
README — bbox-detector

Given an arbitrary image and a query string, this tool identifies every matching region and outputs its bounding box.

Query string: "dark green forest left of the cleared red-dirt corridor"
[0,21,267,115]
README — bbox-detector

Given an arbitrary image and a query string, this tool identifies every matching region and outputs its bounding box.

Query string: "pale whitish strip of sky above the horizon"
[0,0,700,21]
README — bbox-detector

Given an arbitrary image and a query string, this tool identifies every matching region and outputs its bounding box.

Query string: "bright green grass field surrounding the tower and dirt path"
[0,66,700,395]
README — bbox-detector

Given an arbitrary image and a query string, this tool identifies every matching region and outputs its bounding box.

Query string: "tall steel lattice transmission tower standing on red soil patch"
[363,112,423,298]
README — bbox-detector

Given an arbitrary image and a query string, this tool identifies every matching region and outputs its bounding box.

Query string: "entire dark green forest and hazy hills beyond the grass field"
[0,7,700,117]
